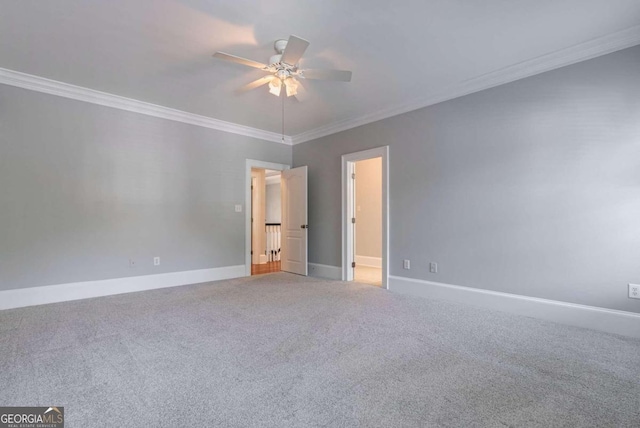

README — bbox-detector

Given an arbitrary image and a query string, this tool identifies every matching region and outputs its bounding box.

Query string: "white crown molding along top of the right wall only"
[292,25,640,144]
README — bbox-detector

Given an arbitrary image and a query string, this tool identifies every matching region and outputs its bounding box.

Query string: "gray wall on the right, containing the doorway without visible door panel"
[293,47,640,312]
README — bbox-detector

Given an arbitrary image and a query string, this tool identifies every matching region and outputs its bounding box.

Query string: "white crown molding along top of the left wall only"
[0,68,292,145]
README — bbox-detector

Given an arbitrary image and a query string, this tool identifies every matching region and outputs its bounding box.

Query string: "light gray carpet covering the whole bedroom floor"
[0,273,640,428]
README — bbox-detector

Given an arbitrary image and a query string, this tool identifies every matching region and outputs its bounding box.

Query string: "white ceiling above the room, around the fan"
[0,0,640,139]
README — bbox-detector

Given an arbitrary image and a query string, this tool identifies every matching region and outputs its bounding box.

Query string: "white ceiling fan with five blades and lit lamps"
[213,35,351,101]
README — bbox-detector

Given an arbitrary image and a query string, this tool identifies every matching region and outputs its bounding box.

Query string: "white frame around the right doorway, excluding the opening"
[342,146,389,289]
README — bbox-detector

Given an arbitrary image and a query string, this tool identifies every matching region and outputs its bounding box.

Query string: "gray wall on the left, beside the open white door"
[0,85,291,289]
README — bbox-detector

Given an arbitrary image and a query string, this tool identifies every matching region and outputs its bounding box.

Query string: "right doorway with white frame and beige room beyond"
[342,146,389,288]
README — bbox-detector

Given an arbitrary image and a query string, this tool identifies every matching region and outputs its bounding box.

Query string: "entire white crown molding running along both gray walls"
[0,25,640,145]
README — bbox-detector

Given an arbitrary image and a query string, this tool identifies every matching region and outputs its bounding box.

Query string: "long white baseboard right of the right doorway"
[389,276,640,338]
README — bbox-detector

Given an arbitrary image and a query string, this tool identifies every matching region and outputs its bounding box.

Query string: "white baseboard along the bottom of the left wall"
[0,265,245,310]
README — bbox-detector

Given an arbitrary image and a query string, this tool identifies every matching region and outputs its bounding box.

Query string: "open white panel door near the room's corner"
[280,166,309,276]
